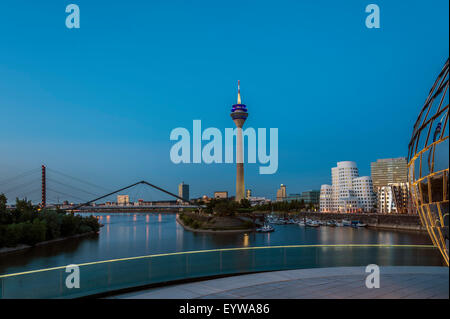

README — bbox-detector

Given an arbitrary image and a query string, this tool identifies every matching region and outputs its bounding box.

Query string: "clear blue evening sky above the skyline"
[0,0,449,202]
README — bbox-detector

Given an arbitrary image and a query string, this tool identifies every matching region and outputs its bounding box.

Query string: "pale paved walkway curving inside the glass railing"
[112,267,449,299]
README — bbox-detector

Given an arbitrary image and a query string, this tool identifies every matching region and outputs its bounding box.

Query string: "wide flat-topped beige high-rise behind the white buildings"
[370,157,408,192]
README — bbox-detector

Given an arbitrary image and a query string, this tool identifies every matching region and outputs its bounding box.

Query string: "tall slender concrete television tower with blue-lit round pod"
[231,81,248,202]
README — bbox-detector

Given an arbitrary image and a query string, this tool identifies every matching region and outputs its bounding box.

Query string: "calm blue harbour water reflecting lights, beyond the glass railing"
[0,213,443,274]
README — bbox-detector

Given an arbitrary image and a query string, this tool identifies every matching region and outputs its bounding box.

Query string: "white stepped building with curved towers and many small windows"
[320,161,375,213]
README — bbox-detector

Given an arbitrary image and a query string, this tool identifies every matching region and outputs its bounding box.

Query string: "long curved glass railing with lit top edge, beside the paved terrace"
[0,244,435,298]
